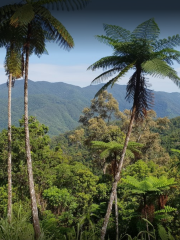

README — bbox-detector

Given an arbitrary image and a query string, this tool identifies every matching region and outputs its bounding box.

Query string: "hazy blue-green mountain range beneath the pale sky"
[0,80,180,136]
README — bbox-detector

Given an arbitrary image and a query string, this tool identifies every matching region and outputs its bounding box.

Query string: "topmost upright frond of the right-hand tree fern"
[132,18,160,40]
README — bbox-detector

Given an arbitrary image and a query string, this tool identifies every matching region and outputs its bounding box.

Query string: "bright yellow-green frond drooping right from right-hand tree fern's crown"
[141,58,180,87]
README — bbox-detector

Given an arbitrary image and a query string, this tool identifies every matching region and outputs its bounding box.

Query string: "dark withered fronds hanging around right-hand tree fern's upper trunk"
[126,71,153,120]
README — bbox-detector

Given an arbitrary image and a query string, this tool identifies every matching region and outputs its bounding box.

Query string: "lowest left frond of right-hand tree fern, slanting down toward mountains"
[91,63,134,97]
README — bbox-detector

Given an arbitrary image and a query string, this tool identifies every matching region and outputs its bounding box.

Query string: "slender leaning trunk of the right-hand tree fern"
[101,107,136,240]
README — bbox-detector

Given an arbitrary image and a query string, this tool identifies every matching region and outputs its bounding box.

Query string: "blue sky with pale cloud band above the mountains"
[0,0,180,92]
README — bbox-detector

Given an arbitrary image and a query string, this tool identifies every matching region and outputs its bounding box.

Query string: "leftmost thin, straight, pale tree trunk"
[7,74,12,223]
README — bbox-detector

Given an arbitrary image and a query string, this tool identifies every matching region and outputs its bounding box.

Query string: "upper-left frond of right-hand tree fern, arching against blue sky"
[103,23,131,42]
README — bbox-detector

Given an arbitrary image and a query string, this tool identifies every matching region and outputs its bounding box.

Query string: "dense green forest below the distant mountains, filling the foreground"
[0,93,180,240]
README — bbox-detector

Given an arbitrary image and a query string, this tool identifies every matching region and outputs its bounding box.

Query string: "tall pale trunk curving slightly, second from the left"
[24,24,41,240]
